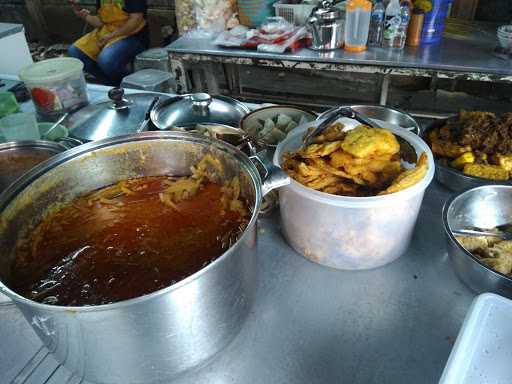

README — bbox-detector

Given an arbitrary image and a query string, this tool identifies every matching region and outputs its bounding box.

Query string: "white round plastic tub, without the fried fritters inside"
[274,119,435,270]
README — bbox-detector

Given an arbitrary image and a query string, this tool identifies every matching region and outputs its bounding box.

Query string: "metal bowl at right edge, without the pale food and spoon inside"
[443,185,512,298]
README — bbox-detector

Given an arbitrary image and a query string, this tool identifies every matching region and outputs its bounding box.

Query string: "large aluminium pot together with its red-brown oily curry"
[0,132,289,383]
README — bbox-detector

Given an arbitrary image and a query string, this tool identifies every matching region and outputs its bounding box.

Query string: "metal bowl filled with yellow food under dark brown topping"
[424,111,512,191]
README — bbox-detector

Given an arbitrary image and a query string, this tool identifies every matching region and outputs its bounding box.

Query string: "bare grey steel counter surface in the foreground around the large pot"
[0,182,474,384]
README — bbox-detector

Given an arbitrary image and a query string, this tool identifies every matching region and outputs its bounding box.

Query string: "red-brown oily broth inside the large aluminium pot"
[11,171,249,306]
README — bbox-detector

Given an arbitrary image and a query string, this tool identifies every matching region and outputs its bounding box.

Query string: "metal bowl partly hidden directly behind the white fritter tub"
[318,105,421,135]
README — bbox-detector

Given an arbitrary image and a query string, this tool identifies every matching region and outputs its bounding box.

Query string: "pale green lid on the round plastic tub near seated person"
[19,57,84,83]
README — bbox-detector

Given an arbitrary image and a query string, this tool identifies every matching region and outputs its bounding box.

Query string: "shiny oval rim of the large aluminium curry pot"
[0,131,263,313]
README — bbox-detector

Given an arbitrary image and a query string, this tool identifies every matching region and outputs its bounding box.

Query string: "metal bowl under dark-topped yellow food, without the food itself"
[423,116,512,192]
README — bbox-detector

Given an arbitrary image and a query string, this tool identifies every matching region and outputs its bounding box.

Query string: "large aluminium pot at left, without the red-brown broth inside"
[0,132,289,383]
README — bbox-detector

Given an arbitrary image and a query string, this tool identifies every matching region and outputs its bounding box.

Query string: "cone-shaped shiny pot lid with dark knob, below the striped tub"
[66,88,168,141]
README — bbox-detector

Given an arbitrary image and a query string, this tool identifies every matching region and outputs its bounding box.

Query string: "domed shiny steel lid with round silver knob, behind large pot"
[151,93,250,129]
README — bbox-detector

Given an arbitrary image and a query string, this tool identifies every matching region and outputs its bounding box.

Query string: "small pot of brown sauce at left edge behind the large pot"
[0,140,66,192]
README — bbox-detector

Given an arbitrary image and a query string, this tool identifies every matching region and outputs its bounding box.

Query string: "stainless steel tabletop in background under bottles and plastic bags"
[167,32,512,81]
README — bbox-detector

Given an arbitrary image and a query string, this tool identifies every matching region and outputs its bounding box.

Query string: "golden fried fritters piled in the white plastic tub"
[283,123,428,196]
